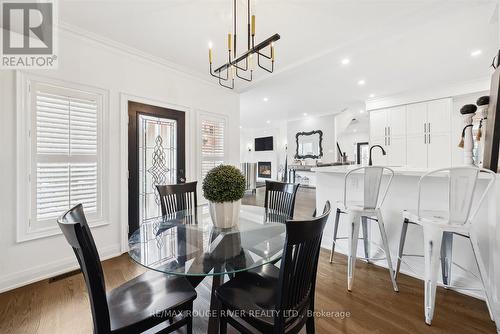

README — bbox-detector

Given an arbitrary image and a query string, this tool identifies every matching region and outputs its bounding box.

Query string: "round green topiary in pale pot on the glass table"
[203,165,245,228]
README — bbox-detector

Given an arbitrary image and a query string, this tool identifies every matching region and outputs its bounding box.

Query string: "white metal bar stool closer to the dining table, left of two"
[330,166,398,291]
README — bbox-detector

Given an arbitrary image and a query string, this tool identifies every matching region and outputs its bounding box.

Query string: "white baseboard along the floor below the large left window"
[0,244,122,293]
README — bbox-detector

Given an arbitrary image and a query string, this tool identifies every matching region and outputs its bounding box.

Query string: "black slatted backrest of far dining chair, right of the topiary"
[264,181,299,223]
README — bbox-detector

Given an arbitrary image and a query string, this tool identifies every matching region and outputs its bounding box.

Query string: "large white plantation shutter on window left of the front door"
[32,83,101,225]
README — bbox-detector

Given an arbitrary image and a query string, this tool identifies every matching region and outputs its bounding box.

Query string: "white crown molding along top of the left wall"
[58,21,238,94]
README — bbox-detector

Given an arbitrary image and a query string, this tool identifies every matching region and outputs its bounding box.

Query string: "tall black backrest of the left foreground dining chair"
[57,204,111,333]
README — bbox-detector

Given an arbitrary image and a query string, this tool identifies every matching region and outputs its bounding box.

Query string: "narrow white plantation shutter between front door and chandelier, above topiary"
[200,117,226,179]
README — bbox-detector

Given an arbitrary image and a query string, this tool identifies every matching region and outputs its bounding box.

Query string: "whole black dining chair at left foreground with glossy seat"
[57,204,196,334]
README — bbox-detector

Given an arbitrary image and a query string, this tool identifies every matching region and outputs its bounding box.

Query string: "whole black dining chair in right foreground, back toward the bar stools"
[215,201,331,334]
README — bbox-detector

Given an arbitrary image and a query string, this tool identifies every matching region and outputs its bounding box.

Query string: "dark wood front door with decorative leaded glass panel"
[128,101,186,236]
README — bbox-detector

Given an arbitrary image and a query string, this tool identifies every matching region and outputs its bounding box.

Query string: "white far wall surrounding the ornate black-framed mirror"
[287,114,335,162]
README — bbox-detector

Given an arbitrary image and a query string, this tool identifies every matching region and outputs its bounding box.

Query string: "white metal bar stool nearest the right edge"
[396,166,496,325]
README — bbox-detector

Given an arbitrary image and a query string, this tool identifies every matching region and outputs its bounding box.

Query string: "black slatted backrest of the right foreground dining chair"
[275,201,331,332]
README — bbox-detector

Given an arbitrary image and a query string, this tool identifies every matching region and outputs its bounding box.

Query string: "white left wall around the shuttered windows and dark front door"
[0,31,240,291]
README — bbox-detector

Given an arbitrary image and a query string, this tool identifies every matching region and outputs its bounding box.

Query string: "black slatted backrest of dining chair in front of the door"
[156,181,198,216]
